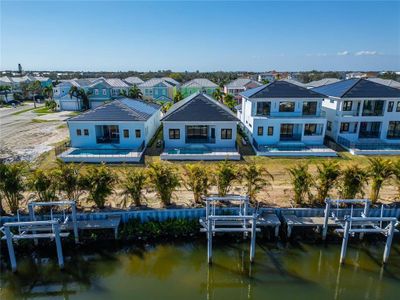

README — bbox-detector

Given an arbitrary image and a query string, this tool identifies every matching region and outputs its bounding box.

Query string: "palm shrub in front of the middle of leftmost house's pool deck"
[82,164,117,208]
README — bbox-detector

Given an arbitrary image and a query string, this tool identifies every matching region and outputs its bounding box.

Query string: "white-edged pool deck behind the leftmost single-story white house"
[58,148,144,163]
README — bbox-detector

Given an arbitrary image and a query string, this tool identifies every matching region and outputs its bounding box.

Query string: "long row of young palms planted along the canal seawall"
[0,158,400,214]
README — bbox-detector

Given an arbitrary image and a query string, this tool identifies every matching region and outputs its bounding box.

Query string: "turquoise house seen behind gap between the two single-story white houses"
[138,77,179,102]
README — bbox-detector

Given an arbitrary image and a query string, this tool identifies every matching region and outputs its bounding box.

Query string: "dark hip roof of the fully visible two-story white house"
[241,80,324,98]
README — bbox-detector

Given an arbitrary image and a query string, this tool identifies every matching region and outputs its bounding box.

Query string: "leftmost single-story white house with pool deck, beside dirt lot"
[59,98,161,162]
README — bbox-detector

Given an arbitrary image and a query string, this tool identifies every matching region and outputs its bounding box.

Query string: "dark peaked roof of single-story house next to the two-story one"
[162,93,239,122]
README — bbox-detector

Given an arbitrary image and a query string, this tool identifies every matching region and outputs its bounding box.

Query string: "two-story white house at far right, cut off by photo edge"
[313,78,400,154]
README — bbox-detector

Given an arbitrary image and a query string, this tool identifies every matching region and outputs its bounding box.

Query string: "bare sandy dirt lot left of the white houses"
[0,103,70,161]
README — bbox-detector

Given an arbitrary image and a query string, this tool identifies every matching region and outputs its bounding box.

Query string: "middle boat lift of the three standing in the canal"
[199,196,260,264]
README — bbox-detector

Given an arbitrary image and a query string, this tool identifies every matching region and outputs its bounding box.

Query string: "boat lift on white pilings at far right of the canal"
[322,199,399,264]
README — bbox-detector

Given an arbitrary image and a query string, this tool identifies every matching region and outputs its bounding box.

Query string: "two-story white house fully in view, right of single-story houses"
[238,80,336,156]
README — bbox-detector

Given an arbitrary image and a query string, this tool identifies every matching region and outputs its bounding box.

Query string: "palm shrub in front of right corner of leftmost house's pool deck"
[122,168,147,207]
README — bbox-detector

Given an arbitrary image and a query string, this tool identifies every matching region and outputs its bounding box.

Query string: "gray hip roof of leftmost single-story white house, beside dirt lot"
[68,98,160,122]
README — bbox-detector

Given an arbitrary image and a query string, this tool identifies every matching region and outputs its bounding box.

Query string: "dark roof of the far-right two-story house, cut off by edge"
[312,78,400,98]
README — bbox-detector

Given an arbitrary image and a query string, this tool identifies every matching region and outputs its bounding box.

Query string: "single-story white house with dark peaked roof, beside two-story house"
[161,93,240,160]
